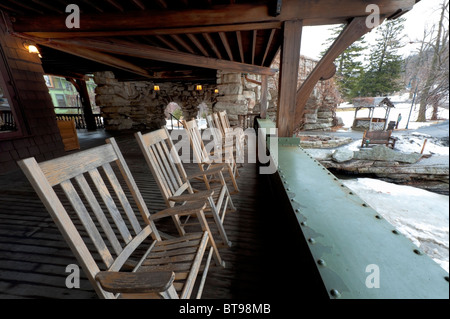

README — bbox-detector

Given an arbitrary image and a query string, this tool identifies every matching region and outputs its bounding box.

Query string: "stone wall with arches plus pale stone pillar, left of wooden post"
[94,71,270,131]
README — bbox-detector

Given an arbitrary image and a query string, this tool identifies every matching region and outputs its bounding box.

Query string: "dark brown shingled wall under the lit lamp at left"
[0,22,64,174]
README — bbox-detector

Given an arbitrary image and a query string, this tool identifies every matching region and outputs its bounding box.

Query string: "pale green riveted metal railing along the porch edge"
[258,120,449,299]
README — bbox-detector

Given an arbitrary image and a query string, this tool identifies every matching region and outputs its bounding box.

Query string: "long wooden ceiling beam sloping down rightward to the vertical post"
[36,39,277,75]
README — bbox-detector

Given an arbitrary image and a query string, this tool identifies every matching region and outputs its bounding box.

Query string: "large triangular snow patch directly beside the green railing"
[342,178,449,272]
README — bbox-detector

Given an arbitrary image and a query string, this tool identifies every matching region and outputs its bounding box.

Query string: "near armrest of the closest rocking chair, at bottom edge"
[95,271,175,293]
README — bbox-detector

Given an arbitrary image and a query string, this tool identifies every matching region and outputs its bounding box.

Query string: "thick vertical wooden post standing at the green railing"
[277,20,303,137]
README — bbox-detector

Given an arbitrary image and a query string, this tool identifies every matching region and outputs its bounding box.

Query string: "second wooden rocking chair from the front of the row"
[135,127,235,246]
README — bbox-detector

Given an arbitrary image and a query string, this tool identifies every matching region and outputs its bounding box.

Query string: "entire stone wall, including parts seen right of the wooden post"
[94,56,339,130]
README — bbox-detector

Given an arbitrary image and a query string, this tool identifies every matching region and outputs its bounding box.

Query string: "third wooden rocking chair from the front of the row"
[183,119,239,194]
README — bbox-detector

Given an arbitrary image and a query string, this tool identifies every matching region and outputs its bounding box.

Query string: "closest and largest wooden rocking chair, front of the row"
[18,139,222,298]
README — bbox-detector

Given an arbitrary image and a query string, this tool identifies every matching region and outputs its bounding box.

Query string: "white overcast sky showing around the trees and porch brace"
[301,0,442,59]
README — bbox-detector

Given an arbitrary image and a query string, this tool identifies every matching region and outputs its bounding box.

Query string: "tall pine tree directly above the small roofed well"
[353,18,405,96]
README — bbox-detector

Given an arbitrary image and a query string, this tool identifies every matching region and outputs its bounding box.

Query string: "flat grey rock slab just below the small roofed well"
[353,145,421,164]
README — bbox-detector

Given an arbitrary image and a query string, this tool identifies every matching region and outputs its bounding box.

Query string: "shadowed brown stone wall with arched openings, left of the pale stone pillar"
[94,71,216,131]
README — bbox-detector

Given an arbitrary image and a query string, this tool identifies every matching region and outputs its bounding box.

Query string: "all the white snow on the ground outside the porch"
[326,95,449,272]
